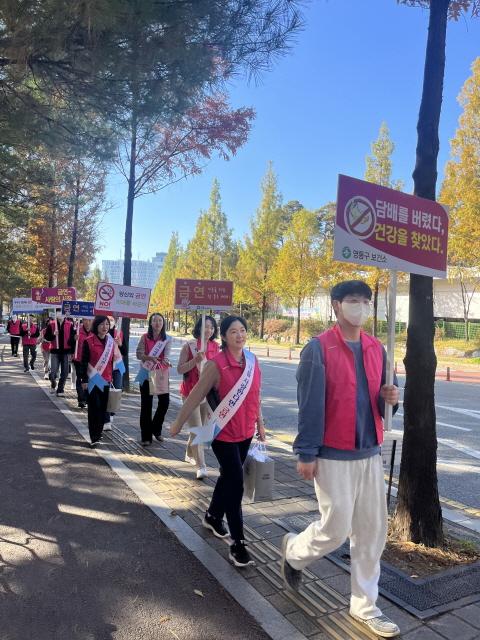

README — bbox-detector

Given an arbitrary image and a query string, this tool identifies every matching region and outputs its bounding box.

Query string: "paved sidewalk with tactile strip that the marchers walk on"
[3,344,480,640]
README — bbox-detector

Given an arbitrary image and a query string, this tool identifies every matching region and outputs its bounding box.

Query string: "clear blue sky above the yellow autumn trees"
[98,0,480,262]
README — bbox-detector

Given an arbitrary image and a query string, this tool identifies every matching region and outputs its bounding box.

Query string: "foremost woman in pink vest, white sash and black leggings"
[170,316,265,567]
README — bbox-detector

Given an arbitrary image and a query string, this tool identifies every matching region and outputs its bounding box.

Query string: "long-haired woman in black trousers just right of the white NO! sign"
[135,313,172,447]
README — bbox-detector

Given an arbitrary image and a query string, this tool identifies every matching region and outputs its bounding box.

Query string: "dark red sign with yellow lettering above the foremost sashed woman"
[175,278,233,311]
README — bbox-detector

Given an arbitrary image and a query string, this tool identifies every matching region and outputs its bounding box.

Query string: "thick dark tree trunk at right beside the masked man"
[393,0,449,547]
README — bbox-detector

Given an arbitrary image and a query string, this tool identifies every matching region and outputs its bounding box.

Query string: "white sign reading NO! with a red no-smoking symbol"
[95,282,151,319]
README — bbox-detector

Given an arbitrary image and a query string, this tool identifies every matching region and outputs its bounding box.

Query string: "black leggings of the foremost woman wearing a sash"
[208,438,252,542]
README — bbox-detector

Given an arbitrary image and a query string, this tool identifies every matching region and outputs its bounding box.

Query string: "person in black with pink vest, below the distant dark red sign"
[44,312,75,397]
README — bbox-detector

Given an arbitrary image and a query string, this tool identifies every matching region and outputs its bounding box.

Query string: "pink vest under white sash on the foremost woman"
[212,349,261,442]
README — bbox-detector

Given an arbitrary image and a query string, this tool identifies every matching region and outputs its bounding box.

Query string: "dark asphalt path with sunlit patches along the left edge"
[0,356,268,640]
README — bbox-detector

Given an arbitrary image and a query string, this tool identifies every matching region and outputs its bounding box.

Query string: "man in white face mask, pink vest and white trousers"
[281,280,400,638]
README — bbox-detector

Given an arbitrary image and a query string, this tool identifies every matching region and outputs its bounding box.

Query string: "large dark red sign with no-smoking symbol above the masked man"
[333,175,448,277]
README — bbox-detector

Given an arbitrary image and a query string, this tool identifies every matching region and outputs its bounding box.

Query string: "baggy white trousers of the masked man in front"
[287,455,387,619]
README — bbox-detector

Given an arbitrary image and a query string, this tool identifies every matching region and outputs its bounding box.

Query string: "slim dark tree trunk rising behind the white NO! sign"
[122,113,137,391]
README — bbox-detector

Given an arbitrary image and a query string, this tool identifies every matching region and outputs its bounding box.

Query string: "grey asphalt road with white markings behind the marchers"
[130,337,480,508]
